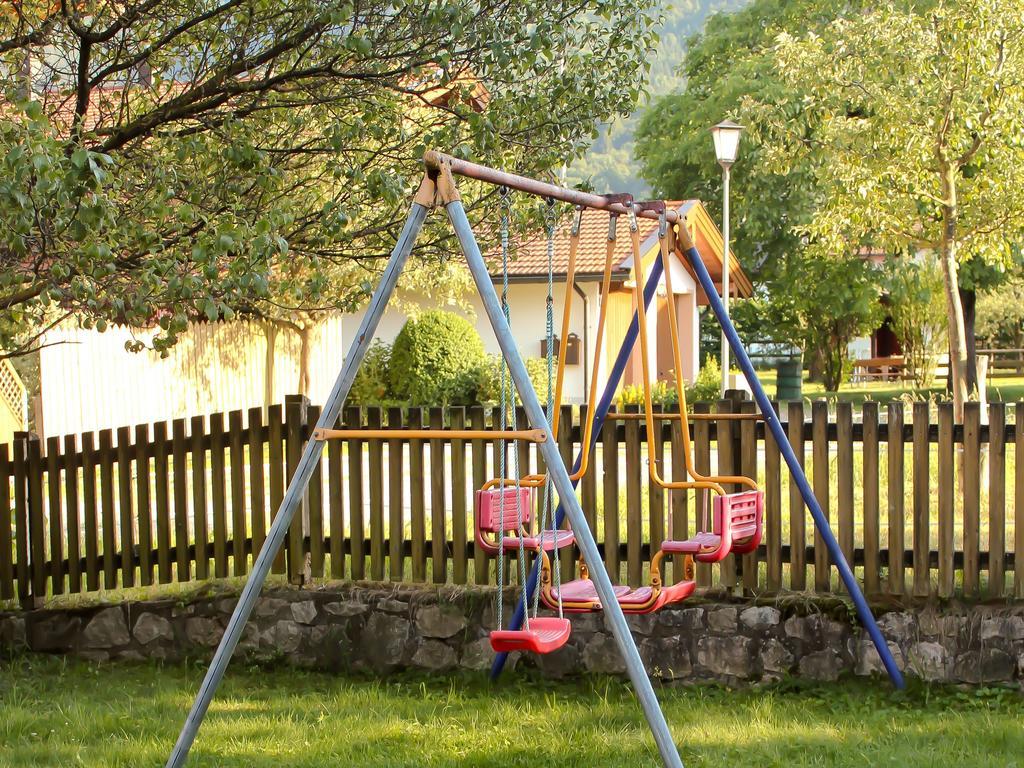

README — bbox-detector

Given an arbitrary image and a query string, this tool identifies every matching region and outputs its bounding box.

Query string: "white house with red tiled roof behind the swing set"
[343,200,753,403]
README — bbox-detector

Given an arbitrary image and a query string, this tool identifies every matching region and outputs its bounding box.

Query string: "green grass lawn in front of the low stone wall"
[0,656,1024,768]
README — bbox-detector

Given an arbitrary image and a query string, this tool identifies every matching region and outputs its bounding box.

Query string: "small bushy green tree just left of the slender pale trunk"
[885,254,948,388]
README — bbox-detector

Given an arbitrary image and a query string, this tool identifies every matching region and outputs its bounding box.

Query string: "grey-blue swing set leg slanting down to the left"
[166,203,428,768]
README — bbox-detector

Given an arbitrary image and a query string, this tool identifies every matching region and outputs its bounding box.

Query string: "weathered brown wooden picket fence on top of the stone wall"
[0,398,1024,604]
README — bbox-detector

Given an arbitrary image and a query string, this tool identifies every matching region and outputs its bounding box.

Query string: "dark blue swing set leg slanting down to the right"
[686,241,903,688]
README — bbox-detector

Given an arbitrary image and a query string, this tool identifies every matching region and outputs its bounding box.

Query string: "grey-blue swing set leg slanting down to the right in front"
[445,201,683,768]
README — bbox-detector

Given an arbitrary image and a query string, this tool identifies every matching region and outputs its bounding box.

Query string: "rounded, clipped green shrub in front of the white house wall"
[389,309,486,406]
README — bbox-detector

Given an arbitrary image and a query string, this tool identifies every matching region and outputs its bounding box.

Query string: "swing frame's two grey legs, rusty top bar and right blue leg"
[166,152,903,768]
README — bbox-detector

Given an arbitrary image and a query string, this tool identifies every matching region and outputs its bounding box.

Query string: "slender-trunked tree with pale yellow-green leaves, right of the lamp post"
[751,0,1024,418]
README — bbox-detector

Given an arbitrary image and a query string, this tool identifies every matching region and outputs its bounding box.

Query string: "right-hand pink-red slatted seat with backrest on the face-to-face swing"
[662,490,765,562]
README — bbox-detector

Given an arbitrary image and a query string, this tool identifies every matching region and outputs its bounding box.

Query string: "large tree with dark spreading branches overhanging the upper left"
[0,0,657,354]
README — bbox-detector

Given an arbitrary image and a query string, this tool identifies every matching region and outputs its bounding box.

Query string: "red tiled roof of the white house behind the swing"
[487,201,694,278]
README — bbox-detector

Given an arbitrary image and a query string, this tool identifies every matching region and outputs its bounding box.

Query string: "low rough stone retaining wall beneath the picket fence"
[0,585,1024,685]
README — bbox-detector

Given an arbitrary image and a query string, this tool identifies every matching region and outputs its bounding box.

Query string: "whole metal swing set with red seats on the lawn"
[166,152,903,768]
